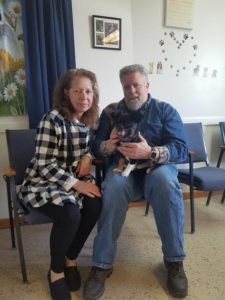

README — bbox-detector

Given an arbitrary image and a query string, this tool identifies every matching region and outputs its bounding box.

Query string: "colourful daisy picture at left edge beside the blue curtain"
[0,0,26,116]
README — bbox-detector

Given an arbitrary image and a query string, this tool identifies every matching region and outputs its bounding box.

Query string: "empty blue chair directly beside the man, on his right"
[178,123,225,233]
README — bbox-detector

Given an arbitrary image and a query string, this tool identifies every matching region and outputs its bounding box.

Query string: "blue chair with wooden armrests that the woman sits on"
[3,129,51,282]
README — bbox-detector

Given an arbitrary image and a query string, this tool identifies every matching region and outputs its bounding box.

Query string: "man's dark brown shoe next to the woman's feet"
[83,267,113,300]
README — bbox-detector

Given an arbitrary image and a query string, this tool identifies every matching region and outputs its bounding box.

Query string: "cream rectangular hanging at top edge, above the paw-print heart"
[165,0,194,29]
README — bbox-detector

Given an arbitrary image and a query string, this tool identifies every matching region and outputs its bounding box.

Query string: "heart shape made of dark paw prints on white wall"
[159,31,198,77]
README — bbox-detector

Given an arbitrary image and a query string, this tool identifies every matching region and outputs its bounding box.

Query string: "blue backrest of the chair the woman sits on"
[6,129,36,185]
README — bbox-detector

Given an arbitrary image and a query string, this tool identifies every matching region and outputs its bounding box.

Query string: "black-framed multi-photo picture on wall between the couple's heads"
[92,15,121,50]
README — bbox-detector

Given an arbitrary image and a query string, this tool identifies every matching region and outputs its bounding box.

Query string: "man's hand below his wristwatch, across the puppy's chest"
[117,132,151,159]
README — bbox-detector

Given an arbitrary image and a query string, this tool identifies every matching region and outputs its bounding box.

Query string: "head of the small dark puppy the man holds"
[112,111,140,143]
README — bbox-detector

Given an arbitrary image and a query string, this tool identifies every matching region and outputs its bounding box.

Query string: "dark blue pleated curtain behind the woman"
[22,0,75,128]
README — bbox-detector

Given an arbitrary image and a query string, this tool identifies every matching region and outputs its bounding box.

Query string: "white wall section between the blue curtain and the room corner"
[72,0,133,109]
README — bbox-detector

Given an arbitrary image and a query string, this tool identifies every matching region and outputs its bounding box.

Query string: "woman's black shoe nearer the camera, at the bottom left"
[47,271,71,300]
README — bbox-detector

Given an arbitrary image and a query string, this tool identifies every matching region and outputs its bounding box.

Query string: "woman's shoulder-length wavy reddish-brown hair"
[53,69,99,126]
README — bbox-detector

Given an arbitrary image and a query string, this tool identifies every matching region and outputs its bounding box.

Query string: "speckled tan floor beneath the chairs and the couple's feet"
[0,198,225,300]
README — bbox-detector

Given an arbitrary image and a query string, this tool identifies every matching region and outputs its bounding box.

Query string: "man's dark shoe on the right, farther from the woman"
[164,261,188,298]
